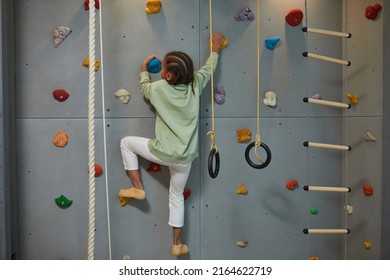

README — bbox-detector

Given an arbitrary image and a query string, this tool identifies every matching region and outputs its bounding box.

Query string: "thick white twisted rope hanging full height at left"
[88,0,96,260]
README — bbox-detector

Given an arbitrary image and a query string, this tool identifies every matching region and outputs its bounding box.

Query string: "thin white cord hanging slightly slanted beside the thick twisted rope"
[99,1,112,260]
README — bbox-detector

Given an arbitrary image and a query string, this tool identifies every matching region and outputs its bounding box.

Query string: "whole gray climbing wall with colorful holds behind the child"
[15,0,382,259]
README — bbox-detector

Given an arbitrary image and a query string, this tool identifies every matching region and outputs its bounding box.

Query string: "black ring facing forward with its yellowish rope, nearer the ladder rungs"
[245,0,271,169]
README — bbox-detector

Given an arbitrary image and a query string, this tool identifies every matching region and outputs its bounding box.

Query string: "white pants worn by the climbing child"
[120,136,191,227]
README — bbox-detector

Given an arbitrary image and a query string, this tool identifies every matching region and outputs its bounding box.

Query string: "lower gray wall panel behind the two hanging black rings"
[201,118,341,259]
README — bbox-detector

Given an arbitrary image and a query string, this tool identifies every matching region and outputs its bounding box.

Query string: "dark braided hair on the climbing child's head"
[164,51,194,85]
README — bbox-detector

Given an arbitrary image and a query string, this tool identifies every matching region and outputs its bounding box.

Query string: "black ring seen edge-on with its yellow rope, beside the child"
[207,0,220,178]
